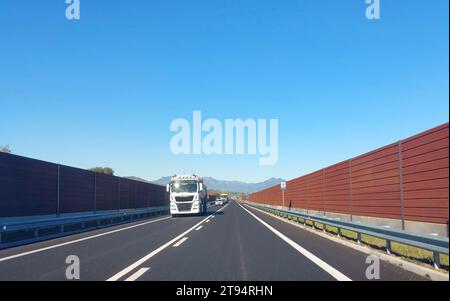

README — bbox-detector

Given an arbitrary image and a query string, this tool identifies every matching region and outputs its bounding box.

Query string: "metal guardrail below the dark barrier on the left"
[0,206,169,250]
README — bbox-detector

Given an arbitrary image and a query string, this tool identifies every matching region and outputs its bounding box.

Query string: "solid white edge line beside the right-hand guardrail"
[239,204,352,281]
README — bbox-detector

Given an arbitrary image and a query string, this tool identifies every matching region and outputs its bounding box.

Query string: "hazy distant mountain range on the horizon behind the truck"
[149,176,284,193]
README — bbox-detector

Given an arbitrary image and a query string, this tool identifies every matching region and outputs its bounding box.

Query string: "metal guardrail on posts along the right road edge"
[245,202,449,269]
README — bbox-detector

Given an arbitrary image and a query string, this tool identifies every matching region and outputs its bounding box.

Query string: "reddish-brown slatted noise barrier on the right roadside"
[250,123,449,224]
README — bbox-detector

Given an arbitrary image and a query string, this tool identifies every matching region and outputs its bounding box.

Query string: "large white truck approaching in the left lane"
[167,175,208,216]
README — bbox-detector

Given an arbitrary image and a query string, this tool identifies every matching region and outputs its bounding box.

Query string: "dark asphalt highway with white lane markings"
[0,201,426,281]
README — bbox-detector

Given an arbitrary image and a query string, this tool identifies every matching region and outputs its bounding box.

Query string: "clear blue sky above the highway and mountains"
[0,0,449,181]
